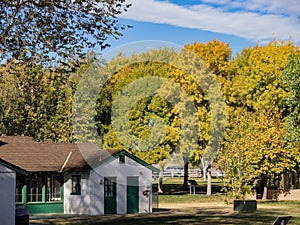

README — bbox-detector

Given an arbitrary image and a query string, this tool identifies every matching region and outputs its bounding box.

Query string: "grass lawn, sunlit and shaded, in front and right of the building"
[30,178,300,225]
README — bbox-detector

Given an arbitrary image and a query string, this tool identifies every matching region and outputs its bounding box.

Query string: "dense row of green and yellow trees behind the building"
[0,40,300,197]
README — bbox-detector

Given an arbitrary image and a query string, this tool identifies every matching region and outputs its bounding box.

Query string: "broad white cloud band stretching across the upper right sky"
[121,0,300,43]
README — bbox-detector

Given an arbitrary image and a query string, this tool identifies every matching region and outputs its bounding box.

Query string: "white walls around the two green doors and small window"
[64,156,152,215]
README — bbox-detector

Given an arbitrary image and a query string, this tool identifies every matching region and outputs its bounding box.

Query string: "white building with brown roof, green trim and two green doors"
[0,136,158,217]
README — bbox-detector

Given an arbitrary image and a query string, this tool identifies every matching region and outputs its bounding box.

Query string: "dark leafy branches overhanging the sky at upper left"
[0,0,130,61]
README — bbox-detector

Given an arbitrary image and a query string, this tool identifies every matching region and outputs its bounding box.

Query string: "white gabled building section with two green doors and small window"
[64,151,152,215]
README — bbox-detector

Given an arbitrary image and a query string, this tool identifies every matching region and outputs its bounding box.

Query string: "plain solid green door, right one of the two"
[127,177,139,213]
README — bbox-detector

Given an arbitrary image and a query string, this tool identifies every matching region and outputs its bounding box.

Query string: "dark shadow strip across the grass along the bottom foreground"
[32,207,300,225]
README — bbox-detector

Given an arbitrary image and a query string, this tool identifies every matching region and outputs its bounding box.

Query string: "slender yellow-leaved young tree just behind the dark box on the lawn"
[218,108,255,199]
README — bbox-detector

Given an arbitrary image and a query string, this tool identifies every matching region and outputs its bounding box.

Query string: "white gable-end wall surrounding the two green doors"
[89,157,152,215]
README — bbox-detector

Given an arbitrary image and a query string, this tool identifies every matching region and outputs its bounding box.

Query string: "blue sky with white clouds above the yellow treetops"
[103,0,300,54]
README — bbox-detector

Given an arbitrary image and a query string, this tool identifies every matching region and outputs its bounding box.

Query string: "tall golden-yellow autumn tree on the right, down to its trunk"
[220,41,298,198]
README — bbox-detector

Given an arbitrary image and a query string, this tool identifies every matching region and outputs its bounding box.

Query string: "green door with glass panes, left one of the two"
[104,177,117,214]
